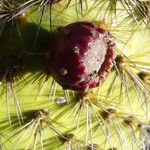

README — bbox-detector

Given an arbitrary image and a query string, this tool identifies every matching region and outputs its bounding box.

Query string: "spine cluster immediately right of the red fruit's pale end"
[110,54,148,117]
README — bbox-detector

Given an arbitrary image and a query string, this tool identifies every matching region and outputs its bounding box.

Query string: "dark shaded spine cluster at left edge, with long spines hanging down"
[0,56,23,126]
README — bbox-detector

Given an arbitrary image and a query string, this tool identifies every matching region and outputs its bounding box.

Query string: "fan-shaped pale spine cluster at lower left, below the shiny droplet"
[11,109,62,150]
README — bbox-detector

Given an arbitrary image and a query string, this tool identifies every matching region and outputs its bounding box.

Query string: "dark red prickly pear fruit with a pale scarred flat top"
[47,22,114,92]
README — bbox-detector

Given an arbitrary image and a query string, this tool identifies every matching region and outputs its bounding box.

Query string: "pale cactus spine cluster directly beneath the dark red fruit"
[67,92,116,147]
